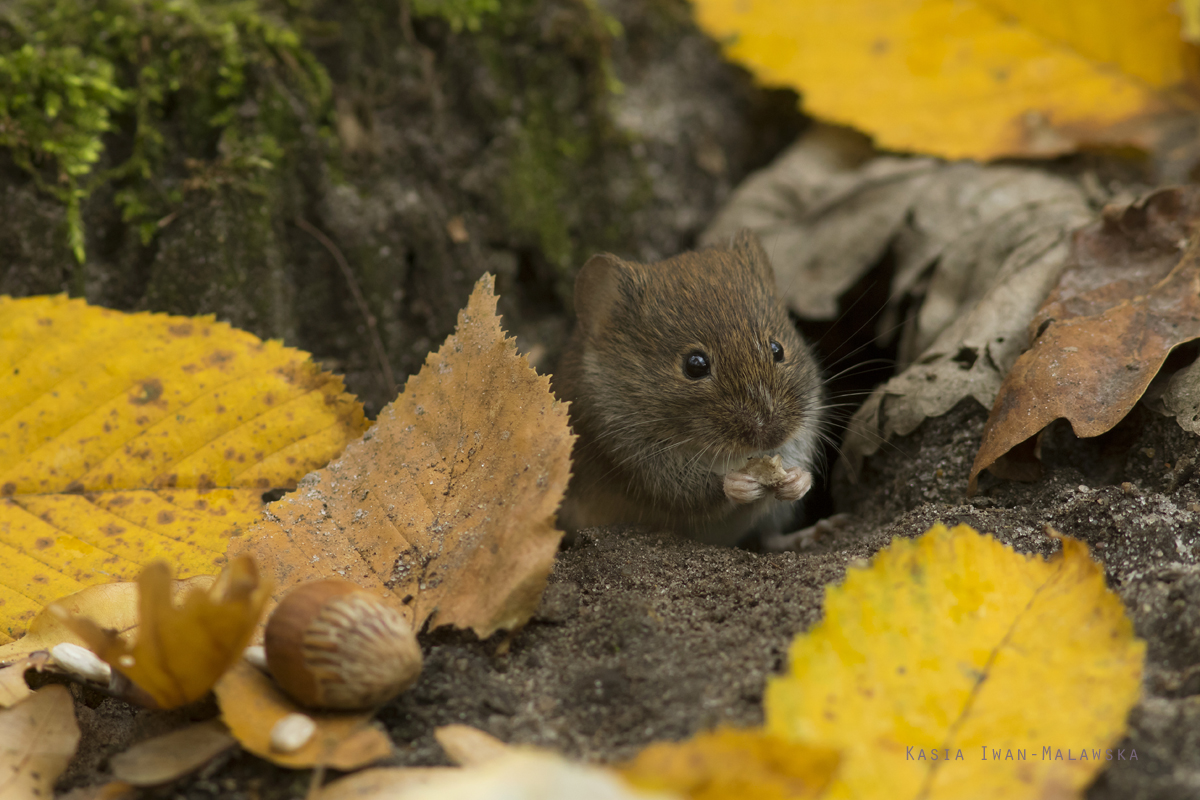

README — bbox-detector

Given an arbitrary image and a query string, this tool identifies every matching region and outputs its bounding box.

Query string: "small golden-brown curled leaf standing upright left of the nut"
[50,558,270,709]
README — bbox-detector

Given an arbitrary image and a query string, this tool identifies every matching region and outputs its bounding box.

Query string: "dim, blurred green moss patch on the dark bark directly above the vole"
[479,0,650,300]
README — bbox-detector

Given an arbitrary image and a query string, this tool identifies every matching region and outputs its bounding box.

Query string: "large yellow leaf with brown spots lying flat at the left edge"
[0,296,366,644]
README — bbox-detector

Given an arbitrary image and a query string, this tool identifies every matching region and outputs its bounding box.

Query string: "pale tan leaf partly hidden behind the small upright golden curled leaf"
[0,575,216,663]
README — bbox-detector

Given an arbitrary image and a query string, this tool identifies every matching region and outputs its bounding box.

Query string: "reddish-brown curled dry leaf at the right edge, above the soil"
[970,187,1200,491]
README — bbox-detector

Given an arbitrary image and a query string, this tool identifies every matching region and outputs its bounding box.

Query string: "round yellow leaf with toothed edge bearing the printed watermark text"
[766,525,1145,800]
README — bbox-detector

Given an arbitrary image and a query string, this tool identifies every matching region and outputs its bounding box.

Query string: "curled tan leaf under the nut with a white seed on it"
[216,661,391,770]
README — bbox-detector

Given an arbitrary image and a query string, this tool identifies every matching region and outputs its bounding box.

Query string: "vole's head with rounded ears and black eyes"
[575,231,821,465]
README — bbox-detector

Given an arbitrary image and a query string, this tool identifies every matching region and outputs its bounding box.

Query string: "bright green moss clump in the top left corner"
[0,0,330,261]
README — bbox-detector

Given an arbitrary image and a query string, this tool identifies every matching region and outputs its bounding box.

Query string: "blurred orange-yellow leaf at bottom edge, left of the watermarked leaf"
[619,728,839,800]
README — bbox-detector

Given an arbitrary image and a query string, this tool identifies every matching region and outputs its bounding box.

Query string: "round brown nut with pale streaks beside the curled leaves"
[265,579,421,709]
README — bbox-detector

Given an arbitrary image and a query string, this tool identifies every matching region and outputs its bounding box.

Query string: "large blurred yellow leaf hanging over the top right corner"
[695,0,1198,158]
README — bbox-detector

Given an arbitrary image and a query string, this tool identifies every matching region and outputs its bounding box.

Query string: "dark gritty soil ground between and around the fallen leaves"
[60,401,1200,800]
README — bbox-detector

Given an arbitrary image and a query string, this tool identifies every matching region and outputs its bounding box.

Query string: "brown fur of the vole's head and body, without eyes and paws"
[554,231,823,543]
